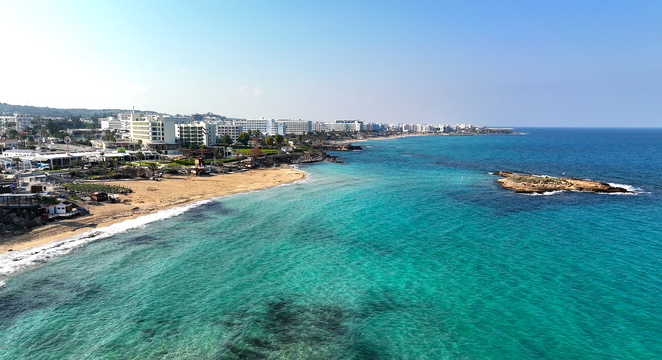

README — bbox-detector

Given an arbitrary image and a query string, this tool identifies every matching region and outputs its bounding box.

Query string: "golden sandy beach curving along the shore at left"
[0,166,305,254]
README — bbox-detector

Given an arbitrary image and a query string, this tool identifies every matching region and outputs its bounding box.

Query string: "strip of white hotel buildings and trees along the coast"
[0,105,512,162]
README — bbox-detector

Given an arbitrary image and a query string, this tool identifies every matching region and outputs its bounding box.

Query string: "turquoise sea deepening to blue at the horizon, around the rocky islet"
[0,128,662,360]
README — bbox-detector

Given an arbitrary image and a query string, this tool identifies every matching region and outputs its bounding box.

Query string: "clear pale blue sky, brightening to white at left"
[0,0,662,127]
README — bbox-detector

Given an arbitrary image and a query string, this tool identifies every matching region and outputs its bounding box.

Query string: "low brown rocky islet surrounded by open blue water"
[493,171,633,194]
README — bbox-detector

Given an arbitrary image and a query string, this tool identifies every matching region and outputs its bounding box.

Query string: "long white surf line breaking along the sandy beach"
[0,198,217,278]
